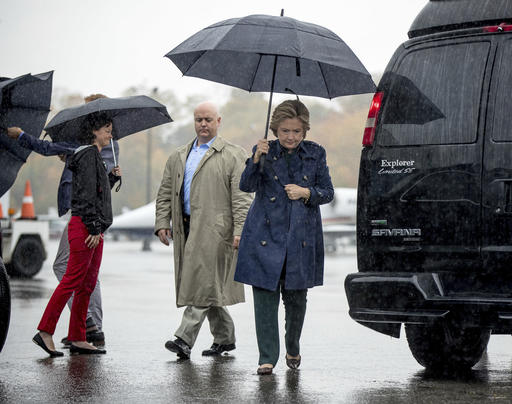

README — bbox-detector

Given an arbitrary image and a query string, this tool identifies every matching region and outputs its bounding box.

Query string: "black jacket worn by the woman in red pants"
[68,145,119,235]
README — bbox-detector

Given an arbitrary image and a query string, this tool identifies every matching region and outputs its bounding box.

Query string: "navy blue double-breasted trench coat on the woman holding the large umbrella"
[235,140,334,290]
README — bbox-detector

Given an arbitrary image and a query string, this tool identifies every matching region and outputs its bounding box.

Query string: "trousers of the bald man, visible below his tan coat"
[174,306,235,348]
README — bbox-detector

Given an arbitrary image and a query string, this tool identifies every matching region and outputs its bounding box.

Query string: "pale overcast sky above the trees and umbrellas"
[0,0,427,97]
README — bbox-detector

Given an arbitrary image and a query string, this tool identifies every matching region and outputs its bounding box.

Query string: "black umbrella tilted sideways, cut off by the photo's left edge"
[0,71,53,196]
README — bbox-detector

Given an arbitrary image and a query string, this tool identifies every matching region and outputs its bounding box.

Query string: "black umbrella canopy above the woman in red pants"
[44,95,172,142]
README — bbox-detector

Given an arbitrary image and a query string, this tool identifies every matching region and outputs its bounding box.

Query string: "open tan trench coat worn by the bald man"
[155,136,252,307]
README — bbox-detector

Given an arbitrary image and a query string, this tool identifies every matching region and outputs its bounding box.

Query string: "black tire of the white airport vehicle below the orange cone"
[8,237,44,278]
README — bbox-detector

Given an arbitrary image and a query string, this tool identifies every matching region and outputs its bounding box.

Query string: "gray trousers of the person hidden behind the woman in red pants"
[53,225,103,330]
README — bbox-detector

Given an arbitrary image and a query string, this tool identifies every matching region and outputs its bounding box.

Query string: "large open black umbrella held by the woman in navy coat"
[165,12,375,137]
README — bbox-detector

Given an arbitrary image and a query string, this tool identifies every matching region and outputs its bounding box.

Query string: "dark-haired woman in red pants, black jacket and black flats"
[33,112,121,356]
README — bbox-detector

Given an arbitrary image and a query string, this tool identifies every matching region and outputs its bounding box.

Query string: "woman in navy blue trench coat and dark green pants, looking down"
[235,100,334,375]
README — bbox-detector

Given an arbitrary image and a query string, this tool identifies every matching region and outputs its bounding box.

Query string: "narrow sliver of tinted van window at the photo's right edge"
[492,40,512,142]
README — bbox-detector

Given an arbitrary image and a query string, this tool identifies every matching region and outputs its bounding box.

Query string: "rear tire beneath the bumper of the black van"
[405,324,491,370]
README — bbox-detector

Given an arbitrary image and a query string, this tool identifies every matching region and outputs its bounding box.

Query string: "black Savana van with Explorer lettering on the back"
[345,0,512,368]
